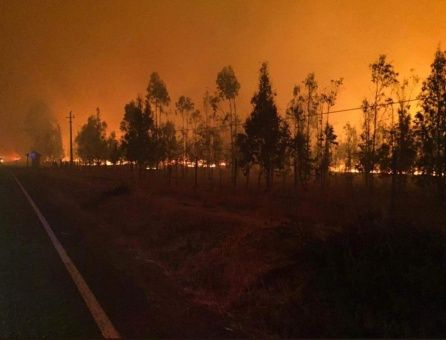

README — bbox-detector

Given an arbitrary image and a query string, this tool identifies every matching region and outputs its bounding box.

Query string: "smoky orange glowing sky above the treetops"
[0,0,446,152]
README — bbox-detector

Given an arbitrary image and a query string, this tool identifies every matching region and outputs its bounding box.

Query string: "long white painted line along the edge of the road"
[12,174,120,339]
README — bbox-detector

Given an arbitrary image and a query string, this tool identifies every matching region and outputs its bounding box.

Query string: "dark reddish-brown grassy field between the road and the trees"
[17,166,446,337]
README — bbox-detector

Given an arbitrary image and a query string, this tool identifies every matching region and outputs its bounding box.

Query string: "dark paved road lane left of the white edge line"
[0,169,100,338]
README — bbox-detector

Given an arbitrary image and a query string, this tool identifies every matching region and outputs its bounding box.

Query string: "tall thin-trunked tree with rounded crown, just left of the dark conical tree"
[216,66,240,186]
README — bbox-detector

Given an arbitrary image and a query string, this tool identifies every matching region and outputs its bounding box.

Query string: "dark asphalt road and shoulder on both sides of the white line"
[0,167,240,338]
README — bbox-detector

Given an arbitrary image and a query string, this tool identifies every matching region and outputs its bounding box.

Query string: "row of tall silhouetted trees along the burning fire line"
[72,46,446,197]
